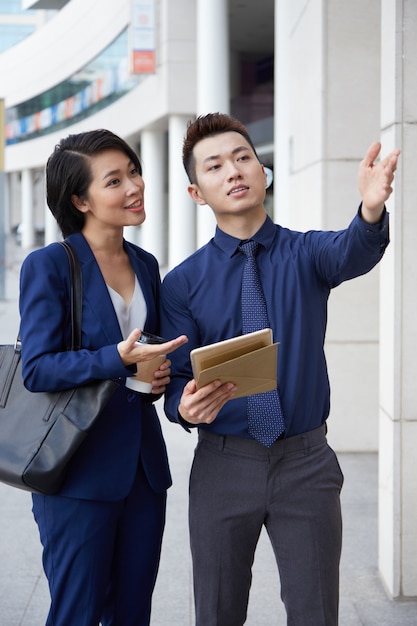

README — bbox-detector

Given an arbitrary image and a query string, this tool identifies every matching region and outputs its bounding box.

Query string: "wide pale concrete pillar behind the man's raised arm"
[274,0,380,451]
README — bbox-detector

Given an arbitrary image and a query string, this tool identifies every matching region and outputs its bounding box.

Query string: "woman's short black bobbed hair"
[46,129,142,237]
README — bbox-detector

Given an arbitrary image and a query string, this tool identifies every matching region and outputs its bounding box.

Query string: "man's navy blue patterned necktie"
[239,240,285,447]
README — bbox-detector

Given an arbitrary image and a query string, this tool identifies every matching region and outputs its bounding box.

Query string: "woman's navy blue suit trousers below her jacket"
[33,460,166,626]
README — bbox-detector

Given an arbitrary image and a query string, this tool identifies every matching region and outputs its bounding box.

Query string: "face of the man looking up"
[188,131,266,217]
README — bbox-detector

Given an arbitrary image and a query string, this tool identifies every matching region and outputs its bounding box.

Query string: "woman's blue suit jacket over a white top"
[20,233,171,500]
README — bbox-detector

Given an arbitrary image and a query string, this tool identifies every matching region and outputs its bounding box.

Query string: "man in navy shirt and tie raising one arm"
[158,113,399,626]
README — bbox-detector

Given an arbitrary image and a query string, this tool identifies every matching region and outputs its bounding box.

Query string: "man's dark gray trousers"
[189,425,343,626]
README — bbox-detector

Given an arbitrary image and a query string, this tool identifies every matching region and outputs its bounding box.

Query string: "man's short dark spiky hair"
[182,113,258,184]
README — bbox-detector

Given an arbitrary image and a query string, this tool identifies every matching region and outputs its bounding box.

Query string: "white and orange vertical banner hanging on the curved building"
[131,0,156,74]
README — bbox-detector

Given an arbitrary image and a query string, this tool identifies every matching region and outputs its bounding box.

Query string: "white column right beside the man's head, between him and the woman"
[168,115,196,268]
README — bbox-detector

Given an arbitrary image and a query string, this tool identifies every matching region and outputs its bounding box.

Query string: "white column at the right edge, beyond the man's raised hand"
[378,0,417,597]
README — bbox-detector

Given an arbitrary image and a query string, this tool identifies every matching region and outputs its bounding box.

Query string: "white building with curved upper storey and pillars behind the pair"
[0,0,417,597]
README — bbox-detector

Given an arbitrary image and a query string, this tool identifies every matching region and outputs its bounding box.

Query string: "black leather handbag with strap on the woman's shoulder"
[0,242,118,494]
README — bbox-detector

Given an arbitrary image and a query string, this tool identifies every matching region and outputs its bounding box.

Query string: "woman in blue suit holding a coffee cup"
[20,130,187,626]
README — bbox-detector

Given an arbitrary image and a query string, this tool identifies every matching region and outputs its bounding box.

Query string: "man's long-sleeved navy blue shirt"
[161,211,389,437]
